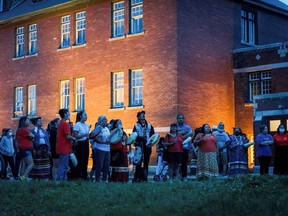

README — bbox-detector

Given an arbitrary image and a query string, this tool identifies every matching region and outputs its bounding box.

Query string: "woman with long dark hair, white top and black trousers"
[73,111,90,180]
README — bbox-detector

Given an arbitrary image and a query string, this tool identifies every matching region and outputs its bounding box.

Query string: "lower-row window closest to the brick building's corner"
[130,69,143,106]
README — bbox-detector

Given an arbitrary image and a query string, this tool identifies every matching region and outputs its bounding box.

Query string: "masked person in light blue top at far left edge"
[0,128,17,180]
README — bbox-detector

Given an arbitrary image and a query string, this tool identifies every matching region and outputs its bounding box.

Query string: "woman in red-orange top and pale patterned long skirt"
[194,124,218,180]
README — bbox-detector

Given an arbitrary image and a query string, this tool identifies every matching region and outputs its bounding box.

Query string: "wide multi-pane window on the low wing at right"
[249,71,272,102]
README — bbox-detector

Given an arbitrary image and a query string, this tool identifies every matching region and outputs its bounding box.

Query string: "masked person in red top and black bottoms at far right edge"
[273,124,288,175]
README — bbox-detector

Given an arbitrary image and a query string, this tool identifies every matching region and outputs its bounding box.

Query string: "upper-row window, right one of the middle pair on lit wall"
[76,11,86,45]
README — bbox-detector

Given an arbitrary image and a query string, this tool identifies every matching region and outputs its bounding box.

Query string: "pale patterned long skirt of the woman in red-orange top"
[196,150,218,179]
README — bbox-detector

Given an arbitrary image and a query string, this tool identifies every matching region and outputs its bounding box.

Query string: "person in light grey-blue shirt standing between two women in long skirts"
[212,122,230,176]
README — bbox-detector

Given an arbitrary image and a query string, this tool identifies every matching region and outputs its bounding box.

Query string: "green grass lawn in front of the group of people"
[0,176,288,216]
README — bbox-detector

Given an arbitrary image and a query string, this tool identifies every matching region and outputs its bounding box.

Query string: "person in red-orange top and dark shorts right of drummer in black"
[164,123,183,182]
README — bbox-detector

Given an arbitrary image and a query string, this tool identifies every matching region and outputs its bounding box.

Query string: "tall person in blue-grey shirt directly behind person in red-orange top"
[177,114,193,182]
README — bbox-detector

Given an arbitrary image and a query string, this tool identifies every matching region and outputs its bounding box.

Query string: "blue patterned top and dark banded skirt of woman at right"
[227,135,248,176]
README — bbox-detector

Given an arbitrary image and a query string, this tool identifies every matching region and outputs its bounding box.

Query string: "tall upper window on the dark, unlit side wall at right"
[241,9,256,44]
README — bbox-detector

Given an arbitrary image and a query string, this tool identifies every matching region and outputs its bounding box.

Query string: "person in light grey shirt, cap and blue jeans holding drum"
[89,116,110,182]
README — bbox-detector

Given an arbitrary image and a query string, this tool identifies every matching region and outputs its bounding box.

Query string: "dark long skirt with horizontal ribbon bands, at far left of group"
[29,145,51,179]
